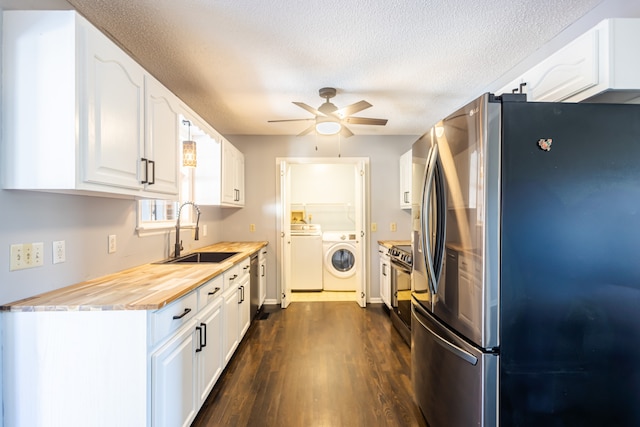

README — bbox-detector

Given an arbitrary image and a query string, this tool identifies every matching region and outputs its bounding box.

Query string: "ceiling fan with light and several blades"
[269,87,387,138]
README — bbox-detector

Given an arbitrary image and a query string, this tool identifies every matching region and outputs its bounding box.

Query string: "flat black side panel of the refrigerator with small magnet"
[500,103,640,427]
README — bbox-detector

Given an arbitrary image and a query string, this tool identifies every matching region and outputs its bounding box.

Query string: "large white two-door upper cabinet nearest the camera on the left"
[2,11,178,198]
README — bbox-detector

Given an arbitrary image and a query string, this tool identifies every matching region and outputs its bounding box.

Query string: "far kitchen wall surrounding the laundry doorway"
[221,135,417,300]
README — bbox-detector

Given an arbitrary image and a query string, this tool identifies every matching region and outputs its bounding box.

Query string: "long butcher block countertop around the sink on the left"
[0,242,268,311]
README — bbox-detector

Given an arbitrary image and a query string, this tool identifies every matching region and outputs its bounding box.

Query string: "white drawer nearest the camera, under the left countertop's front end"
[149,292,198,346]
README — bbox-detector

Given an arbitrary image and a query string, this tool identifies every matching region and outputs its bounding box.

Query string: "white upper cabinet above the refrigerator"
[496,19,640,103]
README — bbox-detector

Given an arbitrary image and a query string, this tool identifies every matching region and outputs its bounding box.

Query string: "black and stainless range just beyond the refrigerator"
[389,245,413,346]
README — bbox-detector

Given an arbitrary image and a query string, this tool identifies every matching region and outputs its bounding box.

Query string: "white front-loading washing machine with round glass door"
[322,231,360,291]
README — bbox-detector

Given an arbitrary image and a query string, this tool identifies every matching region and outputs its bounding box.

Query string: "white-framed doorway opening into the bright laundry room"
[276,157,369,308]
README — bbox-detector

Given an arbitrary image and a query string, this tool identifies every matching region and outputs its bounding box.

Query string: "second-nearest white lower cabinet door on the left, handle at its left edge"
[197,298,223,406]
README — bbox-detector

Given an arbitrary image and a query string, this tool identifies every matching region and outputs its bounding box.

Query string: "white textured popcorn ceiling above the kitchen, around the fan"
[0,0,635,135]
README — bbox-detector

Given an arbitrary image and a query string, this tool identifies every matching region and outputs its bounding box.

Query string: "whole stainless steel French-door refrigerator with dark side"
[411,94,640,427]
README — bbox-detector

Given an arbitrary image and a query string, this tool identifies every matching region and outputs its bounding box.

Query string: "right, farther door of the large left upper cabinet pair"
[143,76,179,194]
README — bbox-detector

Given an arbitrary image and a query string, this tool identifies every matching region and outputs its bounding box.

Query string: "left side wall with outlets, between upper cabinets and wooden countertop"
[0,190,228,303]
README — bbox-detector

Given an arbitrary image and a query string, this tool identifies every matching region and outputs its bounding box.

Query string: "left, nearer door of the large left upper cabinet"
[82,23,146,189]
